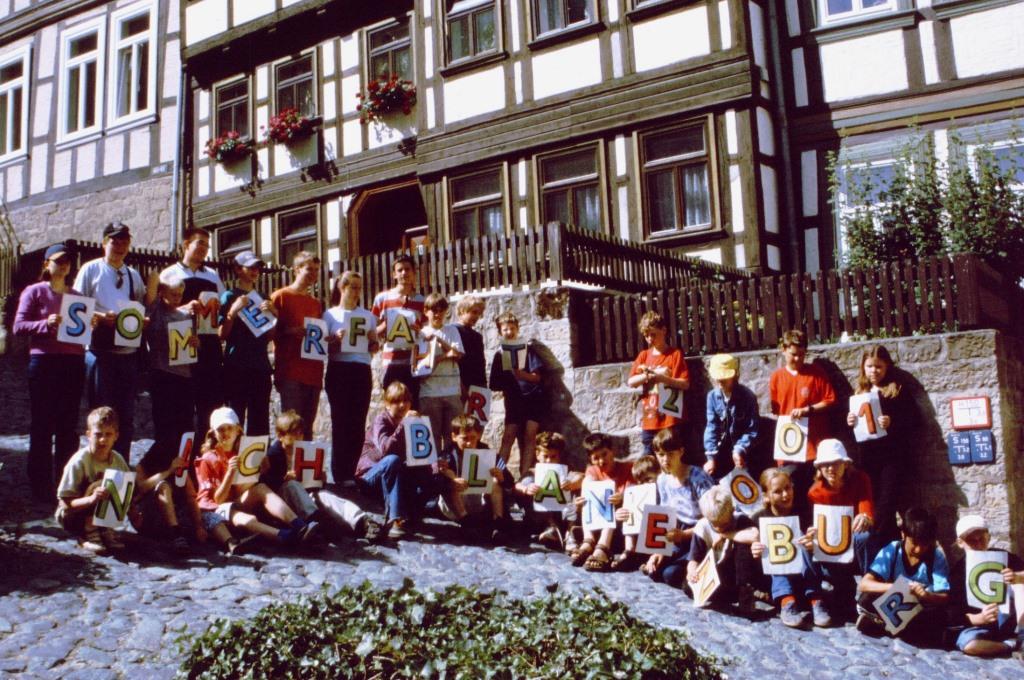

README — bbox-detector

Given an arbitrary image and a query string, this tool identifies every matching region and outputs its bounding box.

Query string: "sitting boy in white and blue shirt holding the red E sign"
[641,430,715,588]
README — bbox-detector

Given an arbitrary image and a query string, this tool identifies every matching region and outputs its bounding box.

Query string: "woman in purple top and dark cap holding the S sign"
[14,245,85,503]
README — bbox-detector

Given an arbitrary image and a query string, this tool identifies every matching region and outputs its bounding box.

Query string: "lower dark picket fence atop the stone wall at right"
[579,255,1024,364]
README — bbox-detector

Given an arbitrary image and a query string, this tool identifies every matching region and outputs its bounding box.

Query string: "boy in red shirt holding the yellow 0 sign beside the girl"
[768,331,836,499]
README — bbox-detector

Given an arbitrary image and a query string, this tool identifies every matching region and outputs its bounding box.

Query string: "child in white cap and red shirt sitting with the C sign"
[196,407,315,555]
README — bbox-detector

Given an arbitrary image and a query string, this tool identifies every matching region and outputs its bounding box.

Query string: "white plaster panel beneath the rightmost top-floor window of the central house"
[633,5,711,72]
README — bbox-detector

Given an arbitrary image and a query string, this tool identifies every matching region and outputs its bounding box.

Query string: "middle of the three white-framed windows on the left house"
[60,20,103,137]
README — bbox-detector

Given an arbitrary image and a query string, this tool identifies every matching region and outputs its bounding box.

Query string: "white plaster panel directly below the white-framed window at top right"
[819,31,907,101]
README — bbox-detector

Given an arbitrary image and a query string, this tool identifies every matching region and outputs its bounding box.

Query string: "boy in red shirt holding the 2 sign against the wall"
[626,311,690,456]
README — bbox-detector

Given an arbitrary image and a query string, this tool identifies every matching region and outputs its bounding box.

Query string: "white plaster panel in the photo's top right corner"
[949,3,1024,78]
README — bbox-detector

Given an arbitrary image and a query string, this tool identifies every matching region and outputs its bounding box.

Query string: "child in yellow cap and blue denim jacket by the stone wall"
[705,354,761,479]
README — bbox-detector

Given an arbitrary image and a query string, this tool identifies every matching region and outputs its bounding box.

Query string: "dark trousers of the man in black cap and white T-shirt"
[85,350,139,461]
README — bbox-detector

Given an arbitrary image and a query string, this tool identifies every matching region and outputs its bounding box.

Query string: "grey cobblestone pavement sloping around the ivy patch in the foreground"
[0,435,1022,680]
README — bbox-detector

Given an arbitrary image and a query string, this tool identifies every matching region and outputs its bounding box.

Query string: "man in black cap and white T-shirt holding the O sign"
[75,222,158,460]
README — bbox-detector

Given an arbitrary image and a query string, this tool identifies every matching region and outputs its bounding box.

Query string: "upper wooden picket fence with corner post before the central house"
[341,222,750,301]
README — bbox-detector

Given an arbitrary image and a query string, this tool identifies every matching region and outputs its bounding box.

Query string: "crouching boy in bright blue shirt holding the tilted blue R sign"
[857,508,949,643]
